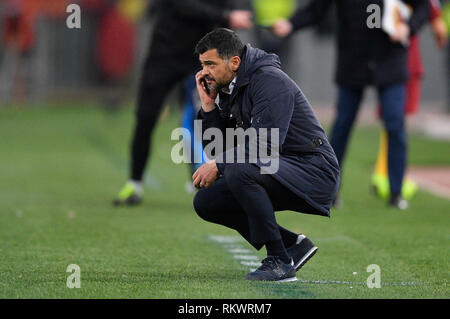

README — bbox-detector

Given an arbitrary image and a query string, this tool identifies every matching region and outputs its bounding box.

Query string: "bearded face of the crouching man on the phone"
[199,49,241,90]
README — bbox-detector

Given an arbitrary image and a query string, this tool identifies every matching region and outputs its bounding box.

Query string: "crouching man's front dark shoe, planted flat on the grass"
[246,256,297,282]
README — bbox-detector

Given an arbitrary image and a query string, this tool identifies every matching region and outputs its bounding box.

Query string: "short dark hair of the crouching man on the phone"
[195,28,245,60]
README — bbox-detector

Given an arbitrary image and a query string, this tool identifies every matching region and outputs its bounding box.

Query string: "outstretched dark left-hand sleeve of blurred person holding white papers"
[289,0,333,31]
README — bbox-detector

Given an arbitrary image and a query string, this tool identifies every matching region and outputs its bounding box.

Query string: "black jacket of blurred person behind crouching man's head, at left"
[151,0,231,66]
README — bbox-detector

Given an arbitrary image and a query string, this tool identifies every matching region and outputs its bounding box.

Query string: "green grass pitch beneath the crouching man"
[0,106,450,298]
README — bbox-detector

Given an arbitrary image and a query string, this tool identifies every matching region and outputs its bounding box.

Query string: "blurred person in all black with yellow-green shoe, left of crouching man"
[113,0,252,205]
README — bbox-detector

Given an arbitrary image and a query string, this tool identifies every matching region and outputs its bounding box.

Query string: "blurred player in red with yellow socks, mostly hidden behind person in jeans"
[372,0,447,200]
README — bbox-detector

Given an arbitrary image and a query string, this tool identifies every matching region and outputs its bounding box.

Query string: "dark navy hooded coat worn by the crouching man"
[198,45,339,216]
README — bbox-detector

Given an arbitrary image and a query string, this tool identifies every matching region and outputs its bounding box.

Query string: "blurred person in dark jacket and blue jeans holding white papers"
[273,0,429,209]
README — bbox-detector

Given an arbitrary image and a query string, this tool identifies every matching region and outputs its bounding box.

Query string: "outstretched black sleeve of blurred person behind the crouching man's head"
[165,0,230,25]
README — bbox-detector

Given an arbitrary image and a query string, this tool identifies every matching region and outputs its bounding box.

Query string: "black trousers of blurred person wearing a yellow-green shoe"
[130,43,199,181]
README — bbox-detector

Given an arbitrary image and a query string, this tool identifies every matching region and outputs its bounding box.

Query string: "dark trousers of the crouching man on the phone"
[194,163,312,250]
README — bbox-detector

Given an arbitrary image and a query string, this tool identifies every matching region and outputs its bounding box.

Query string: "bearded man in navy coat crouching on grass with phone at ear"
[192,28,339,281]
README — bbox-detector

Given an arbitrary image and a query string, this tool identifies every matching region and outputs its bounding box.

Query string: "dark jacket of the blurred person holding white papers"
[290,0,429,88]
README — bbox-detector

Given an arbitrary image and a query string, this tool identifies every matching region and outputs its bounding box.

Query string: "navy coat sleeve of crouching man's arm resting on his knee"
[217,74,295,174]
